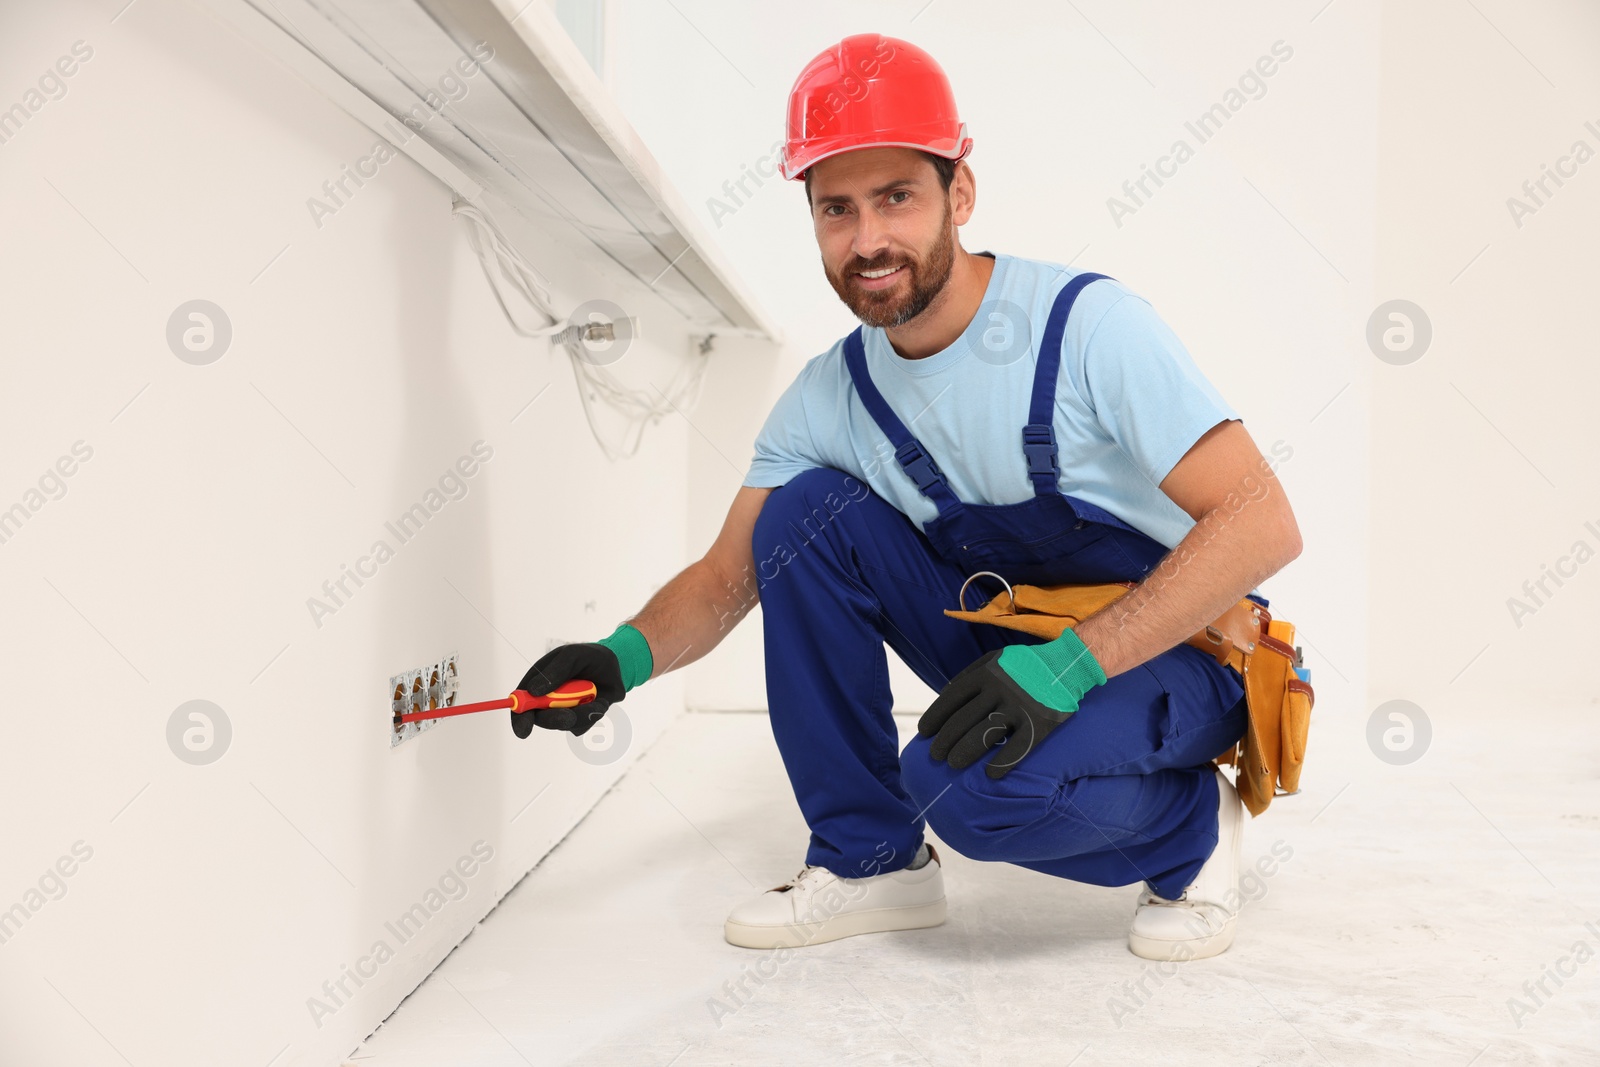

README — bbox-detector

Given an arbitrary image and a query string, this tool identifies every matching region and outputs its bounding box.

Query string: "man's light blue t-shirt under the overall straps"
[744,254,1240,549]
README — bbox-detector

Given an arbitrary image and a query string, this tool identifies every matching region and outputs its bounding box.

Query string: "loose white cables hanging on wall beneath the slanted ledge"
[453,200,706,461]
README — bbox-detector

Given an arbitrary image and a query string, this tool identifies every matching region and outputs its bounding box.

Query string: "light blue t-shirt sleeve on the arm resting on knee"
[1082,294,1240,485]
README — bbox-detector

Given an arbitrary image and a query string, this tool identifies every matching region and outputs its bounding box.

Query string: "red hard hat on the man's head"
[782,34,973,181]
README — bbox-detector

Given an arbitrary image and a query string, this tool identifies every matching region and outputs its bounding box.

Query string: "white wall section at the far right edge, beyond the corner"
[1371,0,1600,716]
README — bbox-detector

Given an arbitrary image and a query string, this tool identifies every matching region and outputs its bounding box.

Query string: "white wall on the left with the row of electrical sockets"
[0,0,707,1067]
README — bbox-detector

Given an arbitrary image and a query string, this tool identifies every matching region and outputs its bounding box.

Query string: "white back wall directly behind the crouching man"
[611,0,1378,744]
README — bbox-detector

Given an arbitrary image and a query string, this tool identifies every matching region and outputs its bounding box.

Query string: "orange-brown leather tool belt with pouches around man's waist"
[944,571,1315,816]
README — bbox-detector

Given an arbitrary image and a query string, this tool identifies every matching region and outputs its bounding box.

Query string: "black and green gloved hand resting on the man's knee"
[917,630,1106,779]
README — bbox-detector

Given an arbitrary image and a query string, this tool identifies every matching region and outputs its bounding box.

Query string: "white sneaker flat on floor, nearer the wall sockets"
[723,843,944,949]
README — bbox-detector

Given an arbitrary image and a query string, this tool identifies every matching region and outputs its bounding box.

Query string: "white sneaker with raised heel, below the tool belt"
[1128,769,1245,960]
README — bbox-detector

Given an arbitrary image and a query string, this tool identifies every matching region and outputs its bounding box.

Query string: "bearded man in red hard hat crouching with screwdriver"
[512,35,1301,960]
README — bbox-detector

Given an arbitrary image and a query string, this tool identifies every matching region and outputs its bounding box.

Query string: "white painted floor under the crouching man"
[349,707,1600,1067]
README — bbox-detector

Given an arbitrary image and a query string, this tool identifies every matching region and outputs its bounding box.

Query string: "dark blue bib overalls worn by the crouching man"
[752,274,1245,897]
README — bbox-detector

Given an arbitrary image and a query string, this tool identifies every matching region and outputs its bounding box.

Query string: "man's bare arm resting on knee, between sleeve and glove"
[1075,421,1302,678]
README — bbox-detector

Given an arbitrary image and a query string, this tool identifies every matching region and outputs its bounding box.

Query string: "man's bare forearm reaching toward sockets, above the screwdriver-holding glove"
[629,486,771,678]
